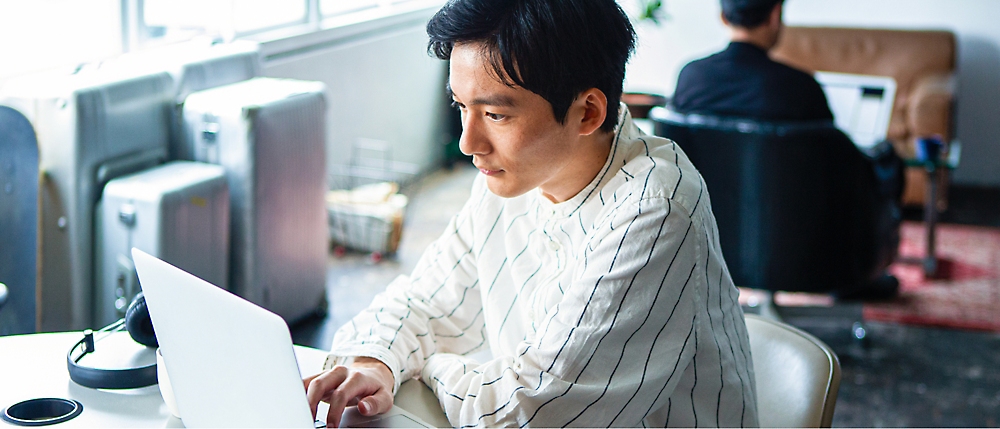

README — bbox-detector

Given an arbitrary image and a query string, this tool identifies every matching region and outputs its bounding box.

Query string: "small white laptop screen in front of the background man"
[814,71,896,149]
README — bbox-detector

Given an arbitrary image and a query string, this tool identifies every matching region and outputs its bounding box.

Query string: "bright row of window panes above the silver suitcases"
[0,0,443,84]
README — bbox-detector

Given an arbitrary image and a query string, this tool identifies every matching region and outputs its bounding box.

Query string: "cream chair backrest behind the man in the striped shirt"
[746,314,840,428]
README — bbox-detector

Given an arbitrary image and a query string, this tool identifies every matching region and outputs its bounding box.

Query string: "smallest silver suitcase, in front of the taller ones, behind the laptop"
[94,161,229,326]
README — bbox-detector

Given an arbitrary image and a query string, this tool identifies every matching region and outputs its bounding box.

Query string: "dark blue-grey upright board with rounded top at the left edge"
[0,106,38,336]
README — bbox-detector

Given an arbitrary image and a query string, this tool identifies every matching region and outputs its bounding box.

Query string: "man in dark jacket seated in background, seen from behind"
[672,0,833,121]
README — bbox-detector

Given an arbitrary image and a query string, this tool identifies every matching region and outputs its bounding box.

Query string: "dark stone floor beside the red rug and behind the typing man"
[292,166,1000,427]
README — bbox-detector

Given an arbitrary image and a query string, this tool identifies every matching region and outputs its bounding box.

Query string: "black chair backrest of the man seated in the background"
[653,108,899,292]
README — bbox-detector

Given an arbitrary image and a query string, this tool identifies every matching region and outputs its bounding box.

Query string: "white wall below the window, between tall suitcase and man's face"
[262,9,447,187]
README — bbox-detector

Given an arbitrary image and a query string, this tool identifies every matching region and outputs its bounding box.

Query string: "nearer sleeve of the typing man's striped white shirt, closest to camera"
[421,198,705,427]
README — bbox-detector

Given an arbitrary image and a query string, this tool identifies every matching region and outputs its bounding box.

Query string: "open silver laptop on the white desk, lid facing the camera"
[132,248,430,428]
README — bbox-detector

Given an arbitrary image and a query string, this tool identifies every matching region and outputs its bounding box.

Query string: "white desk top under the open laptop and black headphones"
[0,332,450,427]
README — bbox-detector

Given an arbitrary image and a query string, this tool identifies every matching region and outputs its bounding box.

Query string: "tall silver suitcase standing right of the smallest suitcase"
[184,78,328,323]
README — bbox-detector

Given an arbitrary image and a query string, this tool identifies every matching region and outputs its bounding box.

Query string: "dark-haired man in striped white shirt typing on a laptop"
[305,0,757,427]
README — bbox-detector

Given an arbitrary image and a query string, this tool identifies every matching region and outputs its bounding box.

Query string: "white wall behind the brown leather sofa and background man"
[626,0,1000,186]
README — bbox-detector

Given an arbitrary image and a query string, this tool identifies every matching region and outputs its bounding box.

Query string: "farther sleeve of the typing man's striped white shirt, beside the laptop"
[324,181,487,393]
